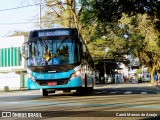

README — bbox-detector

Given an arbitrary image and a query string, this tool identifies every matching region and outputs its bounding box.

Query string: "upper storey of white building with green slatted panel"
[0,36,27,72]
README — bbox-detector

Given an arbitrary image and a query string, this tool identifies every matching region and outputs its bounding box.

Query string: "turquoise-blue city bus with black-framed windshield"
[22,28,95,96]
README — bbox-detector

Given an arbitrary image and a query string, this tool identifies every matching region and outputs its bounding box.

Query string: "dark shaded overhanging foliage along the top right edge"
[93,0,160,22]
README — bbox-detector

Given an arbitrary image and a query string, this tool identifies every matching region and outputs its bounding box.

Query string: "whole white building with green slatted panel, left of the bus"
[0,36,28,89]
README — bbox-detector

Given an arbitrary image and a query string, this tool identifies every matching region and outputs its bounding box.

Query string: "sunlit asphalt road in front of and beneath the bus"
[0,84,160,120]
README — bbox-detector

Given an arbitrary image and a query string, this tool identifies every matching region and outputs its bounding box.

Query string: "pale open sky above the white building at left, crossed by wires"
[0,0,39,38]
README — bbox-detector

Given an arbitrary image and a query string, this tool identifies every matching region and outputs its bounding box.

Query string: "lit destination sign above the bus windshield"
[38,30,70,37]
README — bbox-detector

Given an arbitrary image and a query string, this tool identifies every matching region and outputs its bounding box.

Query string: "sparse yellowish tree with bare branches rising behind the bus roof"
[36,0,106,64]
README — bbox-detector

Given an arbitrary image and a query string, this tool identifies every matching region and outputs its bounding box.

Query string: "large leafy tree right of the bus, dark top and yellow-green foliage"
[81,0,160,83]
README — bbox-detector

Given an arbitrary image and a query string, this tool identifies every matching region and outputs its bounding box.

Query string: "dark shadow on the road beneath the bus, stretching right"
[34,87,158,99]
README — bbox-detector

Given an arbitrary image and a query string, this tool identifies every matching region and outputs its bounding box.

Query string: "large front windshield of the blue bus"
[28,39,80,66]
